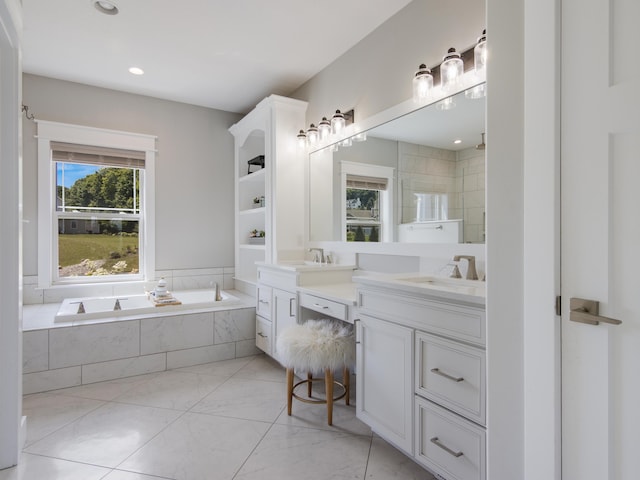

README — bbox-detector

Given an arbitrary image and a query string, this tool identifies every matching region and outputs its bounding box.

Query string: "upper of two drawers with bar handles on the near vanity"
[415,332,486,425]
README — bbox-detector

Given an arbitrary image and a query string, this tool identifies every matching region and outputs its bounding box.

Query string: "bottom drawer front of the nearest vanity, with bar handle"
[415,397,486,480]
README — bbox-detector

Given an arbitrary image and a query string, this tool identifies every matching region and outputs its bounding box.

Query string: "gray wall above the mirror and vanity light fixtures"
[291,0,486,124]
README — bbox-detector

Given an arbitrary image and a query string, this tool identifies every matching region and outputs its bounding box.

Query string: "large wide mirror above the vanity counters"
[309,84,485,243]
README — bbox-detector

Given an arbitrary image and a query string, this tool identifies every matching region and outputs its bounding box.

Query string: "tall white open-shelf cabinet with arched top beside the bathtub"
[229,95,307,295]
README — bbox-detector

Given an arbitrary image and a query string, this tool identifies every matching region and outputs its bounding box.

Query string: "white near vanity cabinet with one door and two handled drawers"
[356,278,486,480]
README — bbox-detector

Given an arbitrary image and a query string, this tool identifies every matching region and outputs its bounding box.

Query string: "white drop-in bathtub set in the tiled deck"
[54,289,240,322]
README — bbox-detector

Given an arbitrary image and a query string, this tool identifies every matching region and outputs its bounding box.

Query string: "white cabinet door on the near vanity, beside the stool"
[356,315,414,455]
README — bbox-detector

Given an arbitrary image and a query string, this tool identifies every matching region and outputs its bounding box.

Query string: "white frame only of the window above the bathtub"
[37,120,157,288]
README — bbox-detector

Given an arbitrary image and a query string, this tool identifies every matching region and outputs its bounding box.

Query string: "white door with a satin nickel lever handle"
[561,0,640,480]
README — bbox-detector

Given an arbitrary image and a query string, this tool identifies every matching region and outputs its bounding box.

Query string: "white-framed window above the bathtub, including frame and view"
[38,121,155,287]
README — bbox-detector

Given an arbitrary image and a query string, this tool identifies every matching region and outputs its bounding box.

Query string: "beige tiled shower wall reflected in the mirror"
[398,142,485,243]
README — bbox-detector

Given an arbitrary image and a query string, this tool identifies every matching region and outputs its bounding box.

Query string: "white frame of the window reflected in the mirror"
[340,161,395,242]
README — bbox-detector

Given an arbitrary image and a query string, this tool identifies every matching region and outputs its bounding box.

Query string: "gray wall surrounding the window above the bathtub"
[22,74,241,275]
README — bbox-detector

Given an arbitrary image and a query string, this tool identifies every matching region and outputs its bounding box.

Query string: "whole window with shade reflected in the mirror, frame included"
[341,162,393,242]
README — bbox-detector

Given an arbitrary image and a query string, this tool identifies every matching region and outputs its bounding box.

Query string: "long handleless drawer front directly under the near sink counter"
[358,288,485,346]
